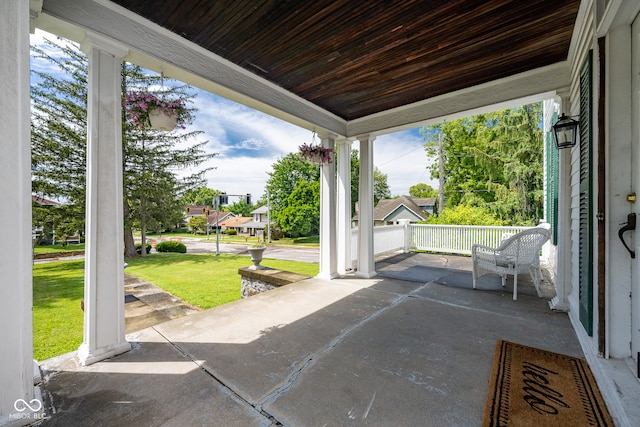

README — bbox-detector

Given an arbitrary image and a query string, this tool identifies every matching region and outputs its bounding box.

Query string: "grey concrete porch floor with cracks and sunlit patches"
[37,254,582,426]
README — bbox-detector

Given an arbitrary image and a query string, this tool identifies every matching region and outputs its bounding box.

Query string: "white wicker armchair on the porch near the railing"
[471,226,549,300]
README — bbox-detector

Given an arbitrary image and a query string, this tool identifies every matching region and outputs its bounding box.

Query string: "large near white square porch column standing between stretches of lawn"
[78,36,131,365]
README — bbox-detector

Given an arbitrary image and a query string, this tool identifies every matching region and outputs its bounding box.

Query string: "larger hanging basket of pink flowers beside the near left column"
[123,92,192,131]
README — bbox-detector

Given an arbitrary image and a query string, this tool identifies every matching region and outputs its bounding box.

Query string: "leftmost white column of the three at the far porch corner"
[318,136,338,279]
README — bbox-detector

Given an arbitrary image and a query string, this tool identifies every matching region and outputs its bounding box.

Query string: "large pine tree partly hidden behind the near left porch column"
[31,40,215,256]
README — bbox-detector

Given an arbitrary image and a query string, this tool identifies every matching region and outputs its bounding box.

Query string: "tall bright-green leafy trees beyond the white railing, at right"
[423,103,543,225]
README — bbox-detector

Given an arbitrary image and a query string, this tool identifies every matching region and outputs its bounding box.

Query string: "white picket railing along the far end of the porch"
[351,224,531,261]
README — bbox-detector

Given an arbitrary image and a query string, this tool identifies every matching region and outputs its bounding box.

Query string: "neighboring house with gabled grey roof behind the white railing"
[353,196,435,225]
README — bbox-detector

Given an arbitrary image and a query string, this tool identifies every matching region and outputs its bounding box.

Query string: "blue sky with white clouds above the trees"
[31,30,437,201]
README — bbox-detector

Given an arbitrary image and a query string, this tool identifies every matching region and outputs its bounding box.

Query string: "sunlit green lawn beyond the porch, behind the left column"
[33,253,319,360]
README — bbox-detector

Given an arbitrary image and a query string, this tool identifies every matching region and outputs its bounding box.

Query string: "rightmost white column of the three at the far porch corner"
[356,135,376,278]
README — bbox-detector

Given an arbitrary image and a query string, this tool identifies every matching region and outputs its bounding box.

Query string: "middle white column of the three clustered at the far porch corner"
[337,139,353,274]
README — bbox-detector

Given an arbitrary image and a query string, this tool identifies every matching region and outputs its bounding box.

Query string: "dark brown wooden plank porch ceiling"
[113,0,580,120]
